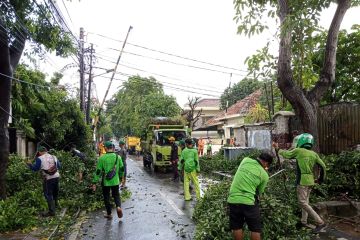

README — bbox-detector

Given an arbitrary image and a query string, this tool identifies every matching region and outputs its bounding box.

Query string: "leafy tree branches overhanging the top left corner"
[0,0,76,57]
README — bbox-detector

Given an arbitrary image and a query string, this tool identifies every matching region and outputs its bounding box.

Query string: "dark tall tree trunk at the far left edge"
[0,19,25,199]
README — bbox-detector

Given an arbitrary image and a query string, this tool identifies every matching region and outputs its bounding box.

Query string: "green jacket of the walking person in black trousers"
[93,152,124,186]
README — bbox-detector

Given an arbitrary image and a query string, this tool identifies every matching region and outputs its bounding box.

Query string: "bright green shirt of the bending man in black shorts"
[227,157,269,205]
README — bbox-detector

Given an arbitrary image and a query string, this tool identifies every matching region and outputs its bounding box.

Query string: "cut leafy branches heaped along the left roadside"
[0,151,131,232]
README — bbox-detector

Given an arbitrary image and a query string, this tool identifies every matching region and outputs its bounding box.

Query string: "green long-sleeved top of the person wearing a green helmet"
[279,148,326,186]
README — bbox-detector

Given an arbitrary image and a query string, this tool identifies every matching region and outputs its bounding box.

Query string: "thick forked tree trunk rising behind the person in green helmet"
[277,0,351,150]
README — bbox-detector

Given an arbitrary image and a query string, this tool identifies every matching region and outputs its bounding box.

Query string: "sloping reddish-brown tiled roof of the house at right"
[194,90,261,129]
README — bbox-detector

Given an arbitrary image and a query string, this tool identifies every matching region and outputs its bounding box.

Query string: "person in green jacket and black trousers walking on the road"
[92,141,124,219]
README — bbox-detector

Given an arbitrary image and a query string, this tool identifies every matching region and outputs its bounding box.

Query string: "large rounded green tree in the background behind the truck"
[106,76,180,137]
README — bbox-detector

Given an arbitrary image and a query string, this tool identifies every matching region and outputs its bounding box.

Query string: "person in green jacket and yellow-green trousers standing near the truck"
[178,138,200,201]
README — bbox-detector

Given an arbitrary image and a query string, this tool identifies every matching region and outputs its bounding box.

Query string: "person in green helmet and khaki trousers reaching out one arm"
[274,133,326,232]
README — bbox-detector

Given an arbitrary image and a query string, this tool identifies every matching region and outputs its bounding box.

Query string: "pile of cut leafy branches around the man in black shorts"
[193,162,310,240]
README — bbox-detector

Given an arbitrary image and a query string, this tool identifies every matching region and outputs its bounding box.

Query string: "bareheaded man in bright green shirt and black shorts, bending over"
[227,151,273,240]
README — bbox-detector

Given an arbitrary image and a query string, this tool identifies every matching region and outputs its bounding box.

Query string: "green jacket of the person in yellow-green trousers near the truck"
[178,148,200,173]
